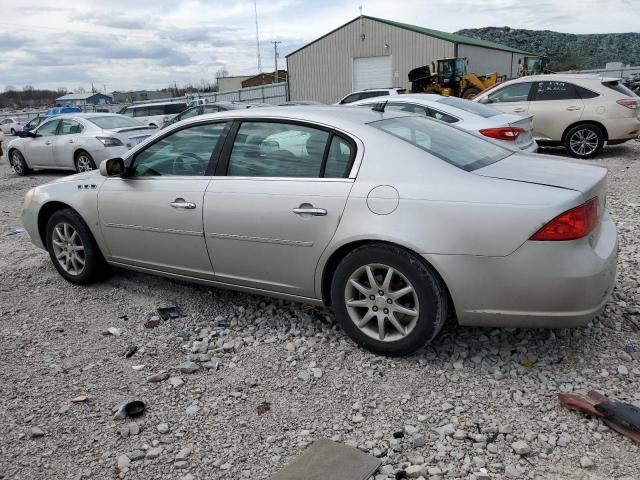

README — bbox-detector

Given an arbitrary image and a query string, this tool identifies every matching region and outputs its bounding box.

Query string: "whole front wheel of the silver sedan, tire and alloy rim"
[47,209,106,285]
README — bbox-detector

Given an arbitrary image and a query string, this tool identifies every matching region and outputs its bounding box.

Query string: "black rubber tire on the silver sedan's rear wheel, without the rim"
[331,244,448,356]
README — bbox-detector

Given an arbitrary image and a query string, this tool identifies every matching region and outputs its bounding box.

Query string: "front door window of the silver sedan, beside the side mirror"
[130,123,226,177]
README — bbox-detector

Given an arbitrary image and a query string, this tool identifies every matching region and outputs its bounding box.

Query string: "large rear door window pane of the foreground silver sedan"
[227,121,329,178]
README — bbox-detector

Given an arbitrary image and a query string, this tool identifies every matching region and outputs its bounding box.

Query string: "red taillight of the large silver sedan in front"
[529,197,598,241]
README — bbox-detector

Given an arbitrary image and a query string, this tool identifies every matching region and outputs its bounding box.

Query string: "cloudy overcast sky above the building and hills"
[0,0,640,91]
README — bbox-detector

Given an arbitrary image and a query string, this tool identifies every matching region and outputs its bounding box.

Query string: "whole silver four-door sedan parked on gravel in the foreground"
[23,107,618,355]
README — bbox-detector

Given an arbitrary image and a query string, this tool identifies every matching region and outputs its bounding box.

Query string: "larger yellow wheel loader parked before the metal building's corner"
[409,58,505,99]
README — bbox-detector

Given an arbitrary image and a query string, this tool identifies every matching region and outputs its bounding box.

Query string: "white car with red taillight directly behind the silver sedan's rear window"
[348,93,538,152]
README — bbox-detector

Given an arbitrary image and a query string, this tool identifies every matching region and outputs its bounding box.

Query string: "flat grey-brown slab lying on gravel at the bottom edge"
[269,438,382,480]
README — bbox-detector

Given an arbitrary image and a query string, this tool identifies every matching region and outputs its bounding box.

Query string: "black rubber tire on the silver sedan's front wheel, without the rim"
[46,208,107,285]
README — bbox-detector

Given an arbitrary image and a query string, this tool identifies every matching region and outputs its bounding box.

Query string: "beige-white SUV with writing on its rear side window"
[474,74,640,158]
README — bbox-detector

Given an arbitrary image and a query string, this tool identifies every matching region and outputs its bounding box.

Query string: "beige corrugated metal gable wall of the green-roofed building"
[287,18,458,103]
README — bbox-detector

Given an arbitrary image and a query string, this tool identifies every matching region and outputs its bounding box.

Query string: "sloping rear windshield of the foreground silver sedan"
[369,116,513,172]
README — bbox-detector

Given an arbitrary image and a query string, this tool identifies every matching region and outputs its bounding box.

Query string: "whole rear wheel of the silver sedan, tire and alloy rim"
[331,244,447,355]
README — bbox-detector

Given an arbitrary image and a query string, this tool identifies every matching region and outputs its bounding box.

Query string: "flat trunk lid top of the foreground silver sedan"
[472,153,607,194]
